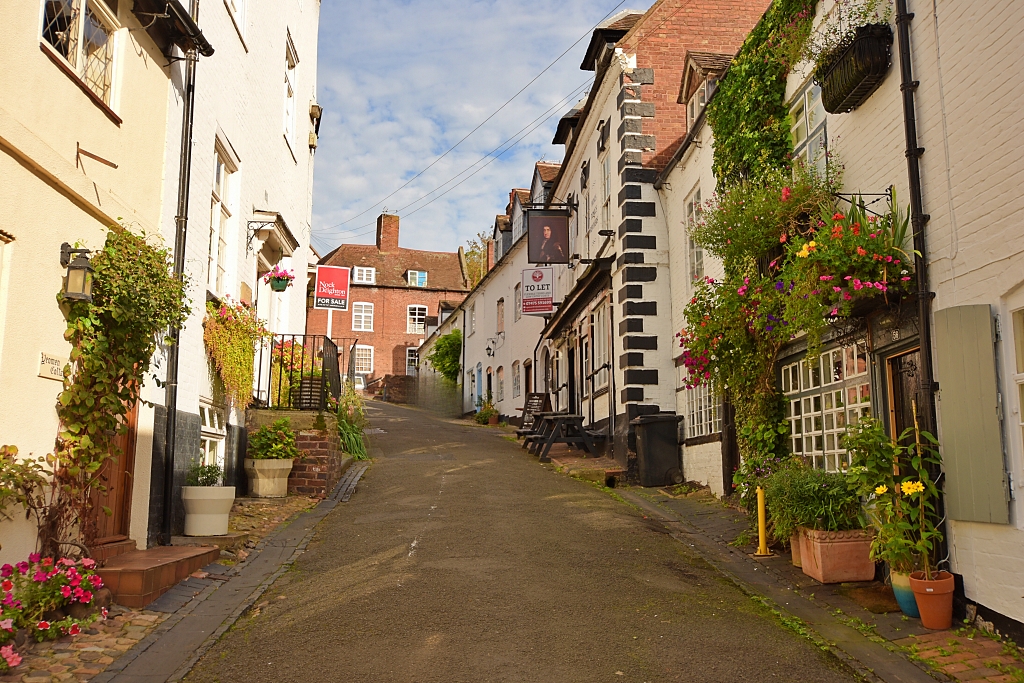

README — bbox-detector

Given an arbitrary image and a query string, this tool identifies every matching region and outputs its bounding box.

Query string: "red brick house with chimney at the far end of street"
[306,214,469,381]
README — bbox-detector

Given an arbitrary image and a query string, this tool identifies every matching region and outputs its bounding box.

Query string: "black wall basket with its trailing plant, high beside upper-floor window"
[805,0,893,114]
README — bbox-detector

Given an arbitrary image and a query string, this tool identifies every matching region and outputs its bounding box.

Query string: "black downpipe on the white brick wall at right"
[896,0,948,561]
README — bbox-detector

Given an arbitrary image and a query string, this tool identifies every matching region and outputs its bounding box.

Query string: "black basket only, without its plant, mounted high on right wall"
[814,24,893,114]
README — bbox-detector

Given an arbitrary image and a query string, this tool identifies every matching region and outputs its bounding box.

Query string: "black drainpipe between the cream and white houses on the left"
[161,0,199,545]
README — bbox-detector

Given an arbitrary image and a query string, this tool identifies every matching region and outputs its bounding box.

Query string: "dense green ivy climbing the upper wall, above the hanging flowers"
[708,0,815,186]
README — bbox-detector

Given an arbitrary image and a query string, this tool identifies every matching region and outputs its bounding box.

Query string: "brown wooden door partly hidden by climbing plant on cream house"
[91,403,138,546]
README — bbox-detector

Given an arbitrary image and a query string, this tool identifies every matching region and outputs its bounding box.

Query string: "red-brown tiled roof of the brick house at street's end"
[319,245,469,292]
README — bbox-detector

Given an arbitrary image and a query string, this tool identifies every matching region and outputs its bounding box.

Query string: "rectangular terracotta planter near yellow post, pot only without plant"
[799,526,874,584]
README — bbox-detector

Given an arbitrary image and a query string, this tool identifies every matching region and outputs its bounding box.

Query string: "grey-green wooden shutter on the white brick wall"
[935,304,1010,524]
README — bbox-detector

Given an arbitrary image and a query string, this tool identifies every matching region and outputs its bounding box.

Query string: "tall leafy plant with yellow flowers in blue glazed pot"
[844,418,927,617]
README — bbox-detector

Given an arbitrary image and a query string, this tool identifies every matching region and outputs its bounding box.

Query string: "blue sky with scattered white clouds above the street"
[312,0,650,254]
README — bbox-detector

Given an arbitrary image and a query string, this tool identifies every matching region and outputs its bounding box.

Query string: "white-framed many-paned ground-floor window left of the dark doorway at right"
[782,342,871,472]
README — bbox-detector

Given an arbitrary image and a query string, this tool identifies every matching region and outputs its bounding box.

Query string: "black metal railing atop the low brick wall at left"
[253,335,355,411]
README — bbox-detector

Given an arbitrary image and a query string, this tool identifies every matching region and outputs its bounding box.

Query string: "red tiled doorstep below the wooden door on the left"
[98,546,220,608]
